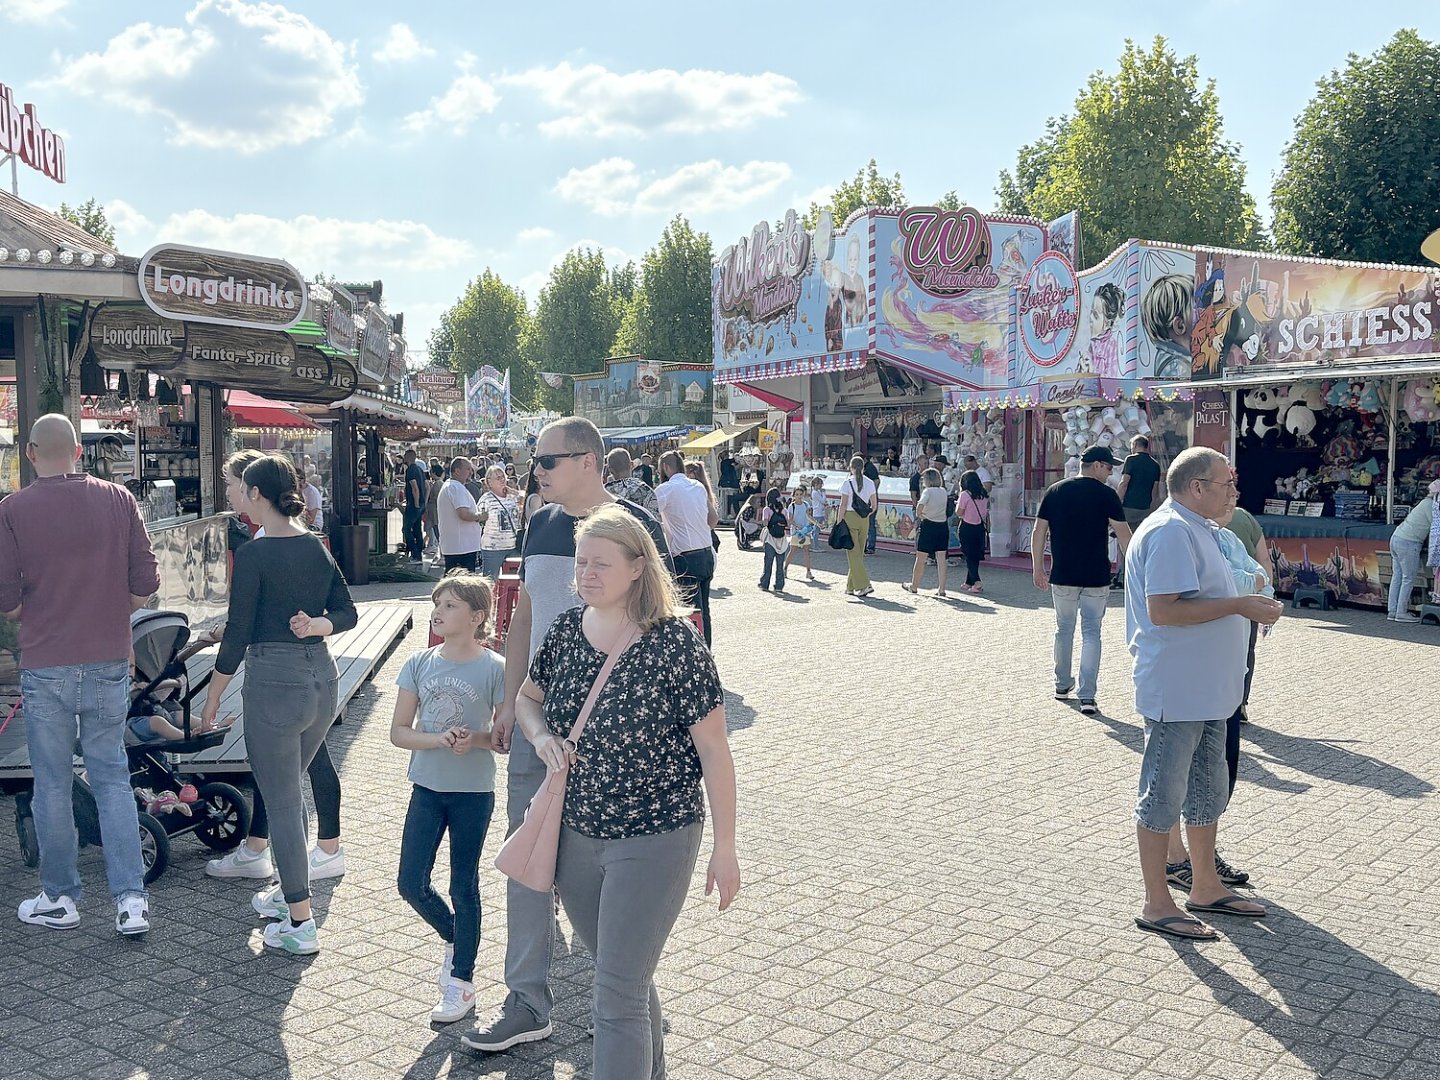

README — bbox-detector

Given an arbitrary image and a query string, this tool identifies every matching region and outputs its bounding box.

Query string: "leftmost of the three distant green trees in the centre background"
[440,266,540,405]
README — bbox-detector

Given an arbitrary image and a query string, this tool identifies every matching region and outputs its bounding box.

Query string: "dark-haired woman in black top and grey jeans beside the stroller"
[202,454,356,953]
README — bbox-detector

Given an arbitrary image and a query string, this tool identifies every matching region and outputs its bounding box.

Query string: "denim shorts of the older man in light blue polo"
[1135,720,1230,832]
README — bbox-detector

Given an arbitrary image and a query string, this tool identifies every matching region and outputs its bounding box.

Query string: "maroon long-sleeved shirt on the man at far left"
[0,472,160,670]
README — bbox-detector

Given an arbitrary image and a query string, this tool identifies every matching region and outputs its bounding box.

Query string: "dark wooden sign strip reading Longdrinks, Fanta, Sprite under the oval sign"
[89,304,356,405]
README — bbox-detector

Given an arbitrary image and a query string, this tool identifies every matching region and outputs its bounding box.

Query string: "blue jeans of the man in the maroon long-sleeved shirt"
[20,660,145,901]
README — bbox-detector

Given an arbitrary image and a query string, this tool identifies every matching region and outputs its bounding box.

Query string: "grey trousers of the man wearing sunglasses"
[505,724,554,1024]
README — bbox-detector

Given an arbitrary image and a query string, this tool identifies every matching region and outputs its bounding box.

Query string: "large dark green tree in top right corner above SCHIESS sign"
[1270,30,1440,264]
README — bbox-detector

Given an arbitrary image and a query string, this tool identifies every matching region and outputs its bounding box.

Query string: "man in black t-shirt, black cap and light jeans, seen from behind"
[1030,446,1130,716]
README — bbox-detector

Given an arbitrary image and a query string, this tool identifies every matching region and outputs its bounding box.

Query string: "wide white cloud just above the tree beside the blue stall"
[554,157,791,217]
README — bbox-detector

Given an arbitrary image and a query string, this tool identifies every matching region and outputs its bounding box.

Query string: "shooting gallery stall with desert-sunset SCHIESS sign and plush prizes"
[1191,248,1440,608]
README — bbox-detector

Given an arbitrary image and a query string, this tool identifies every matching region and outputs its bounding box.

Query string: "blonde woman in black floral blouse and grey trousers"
[497,507,740,1080]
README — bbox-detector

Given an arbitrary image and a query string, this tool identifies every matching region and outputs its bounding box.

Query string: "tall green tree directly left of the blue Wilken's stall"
[613,215,714,364]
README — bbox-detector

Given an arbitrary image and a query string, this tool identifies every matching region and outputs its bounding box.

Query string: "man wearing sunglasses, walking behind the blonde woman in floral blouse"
[461,416,675,1053]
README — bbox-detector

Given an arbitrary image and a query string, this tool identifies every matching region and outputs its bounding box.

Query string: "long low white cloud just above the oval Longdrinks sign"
[105,199,475,276]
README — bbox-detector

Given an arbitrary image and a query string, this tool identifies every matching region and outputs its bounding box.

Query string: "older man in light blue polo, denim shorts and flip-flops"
[1125,446,1282,940]
